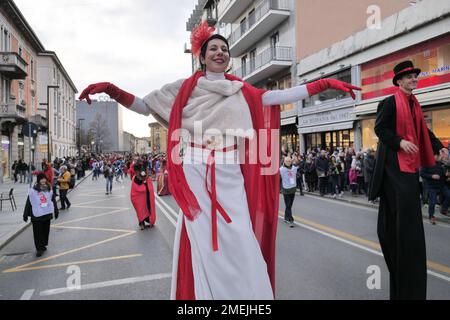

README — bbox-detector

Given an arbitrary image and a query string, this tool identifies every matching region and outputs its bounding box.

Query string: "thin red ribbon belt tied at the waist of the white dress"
[191,142,237,251]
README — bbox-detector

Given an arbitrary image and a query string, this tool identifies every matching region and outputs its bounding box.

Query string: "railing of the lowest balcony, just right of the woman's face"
[234,47,293,79]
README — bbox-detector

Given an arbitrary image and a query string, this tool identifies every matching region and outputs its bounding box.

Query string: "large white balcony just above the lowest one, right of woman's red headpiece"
[228,0,291,57]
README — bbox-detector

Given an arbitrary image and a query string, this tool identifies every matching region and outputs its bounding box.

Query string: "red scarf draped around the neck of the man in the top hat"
[395,89,436,173]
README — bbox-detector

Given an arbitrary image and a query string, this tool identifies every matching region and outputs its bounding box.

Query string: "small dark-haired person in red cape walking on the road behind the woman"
[130,162,156,230]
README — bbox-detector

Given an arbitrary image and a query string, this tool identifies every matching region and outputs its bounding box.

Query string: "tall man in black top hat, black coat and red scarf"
[369,61,444,300]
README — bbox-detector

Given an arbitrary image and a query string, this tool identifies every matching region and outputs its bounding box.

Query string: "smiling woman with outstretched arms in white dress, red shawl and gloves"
[80,22,360,300]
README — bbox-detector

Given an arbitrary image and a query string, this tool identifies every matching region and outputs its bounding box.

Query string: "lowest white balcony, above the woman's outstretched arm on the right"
[234,47,293,84]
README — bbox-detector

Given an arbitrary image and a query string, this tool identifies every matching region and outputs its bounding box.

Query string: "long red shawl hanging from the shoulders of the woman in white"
[167,72,280,299]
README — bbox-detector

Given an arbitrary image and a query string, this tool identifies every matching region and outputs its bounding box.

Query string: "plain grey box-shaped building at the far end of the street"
[76,97,124,153]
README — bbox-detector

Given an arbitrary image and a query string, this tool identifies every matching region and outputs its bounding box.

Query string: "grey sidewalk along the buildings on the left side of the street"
[0,171,91,250]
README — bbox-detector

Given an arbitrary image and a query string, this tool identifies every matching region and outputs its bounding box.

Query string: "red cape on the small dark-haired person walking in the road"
[130,177,156,225]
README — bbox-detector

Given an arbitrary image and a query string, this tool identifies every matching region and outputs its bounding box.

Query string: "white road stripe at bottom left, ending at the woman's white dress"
[39,273,172,297]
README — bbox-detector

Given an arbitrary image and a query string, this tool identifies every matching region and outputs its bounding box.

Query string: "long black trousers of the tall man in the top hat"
[378,151,427,300]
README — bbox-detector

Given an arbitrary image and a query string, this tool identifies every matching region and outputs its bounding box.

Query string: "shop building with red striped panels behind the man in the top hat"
[297,0,450,152]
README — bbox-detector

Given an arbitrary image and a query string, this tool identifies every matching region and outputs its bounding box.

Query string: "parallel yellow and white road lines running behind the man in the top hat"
[279,212,450,282]
